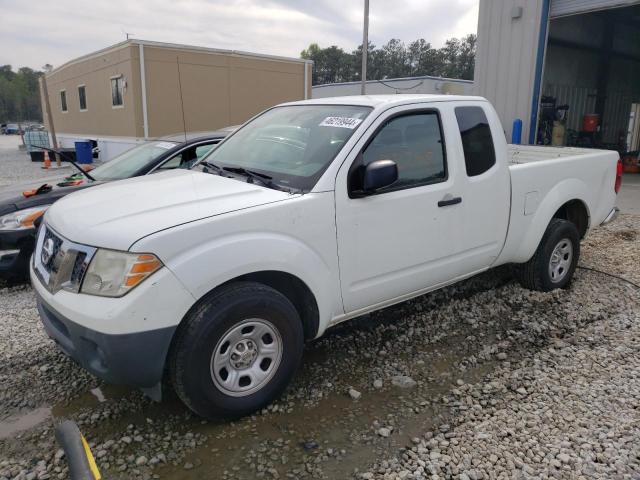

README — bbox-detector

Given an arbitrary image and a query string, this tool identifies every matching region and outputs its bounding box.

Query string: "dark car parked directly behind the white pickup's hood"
[0,130,228,281]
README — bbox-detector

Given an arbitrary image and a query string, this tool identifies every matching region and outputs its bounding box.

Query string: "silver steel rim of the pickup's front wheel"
[210,318,283,397]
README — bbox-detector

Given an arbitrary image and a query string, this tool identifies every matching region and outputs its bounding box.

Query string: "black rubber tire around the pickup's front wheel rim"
[168,282,304,418]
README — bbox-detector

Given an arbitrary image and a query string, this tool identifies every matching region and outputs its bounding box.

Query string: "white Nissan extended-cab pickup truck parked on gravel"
[31,95,621,417]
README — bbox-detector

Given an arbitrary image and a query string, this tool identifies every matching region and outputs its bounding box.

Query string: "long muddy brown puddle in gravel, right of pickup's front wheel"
[155,346,495,480]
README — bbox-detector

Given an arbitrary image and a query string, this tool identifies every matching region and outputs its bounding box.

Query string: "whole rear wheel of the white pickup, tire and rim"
[516,218,580,292]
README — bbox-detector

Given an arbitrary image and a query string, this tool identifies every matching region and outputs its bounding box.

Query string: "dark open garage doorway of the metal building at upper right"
[536,0,640,152]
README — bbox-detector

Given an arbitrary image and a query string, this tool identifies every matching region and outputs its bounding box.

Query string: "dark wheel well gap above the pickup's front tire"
[224,270,320,340]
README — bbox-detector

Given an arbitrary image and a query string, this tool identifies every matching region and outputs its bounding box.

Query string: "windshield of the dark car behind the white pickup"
[90,142,179,180]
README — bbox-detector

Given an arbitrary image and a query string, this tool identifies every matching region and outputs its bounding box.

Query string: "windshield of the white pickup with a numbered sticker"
[198,105,371,191]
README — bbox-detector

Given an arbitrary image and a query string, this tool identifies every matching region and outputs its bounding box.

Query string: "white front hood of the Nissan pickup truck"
[45,170,294,250]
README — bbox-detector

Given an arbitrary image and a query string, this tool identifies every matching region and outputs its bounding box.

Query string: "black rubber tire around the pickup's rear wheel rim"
[515,218,580,292]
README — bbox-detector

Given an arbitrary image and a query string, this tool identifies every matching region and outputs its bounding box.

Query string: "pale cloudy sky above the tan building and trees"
[0,0,479,70]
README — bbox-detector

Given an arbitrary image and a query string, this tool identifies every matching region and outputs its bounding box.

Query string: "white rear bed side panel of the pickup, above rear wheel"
[497,150,618,264]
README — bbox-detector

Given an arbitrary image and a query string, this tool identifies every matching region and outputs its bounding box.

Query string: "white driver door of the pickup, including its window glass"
[335,106,461,313]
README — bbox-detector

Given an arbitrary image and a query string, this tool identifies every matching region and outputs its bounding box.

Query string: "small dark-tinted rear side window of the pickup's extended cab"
[456,107,496,177]
